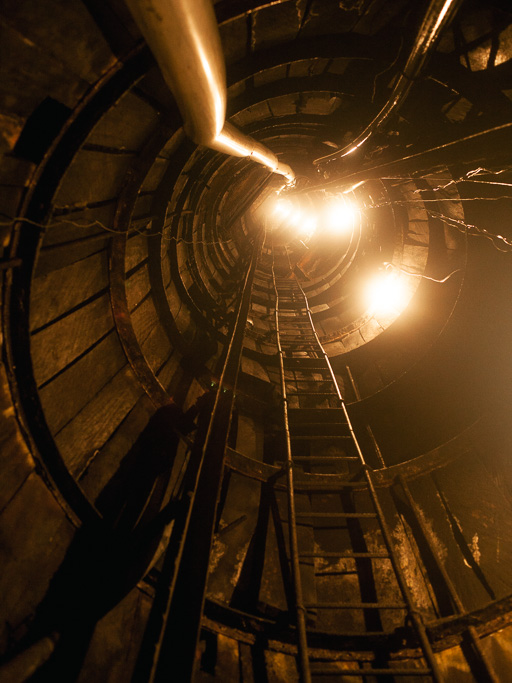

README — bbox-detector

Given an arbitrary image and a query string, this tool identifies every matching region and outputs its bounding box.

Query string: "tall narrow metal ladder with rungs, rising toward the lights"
[272,265,442,683]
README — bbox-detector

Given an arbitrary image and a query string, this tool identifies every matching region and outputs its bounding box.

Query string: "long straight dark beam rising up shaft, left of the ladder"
[145,232,265,683]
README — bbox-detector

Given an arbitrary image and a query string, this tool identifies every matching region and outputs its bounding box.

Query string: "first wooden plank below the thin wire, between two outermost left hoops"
[30,251,108,330]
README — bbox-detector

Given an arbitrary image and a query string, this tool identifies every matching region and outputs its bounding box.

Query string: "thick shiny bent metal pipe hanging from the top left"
[126,0,295,182]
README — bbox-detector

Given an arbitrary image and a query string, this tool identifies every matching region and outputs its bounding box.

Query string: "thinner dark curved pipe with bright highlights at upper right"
[313,0,461,165]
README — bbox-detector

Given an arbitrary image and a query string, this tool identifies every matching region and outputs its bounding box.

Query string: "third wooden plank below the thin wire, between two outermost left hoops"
[39,332,126,434]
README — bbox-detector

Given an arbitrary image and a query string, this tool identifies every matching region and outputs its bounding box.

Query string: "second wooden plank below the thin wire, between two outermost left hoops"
[32,294,113,385]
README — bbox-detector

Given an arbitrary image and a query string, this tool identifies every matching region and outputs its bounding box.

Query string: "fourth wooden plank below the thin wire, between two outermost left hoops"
[55,366,143,477]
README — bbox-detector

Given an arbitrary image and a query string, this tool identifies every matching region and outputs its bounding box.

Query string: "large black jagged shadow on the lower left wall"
[20,405,193,683]
